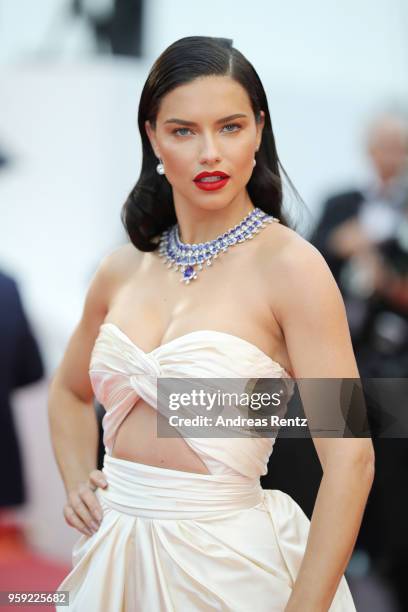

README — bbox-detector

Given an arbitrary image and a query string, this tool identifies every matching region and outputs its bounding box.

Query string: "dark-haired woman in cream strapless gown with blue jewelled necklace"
[49,36,373,612]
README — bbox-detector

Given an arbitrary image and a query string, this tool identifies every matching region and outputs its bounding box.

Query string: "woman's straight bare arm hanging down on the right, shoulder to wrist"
[274,238,374,612]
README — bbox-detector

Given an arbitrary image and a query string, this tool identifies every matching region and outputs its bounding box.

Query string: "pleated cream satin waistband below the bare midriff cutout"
[97,455,264,520]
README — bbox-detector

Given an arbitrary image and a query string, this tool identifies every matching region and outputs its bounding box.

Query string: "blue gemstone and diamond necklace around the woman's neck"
[158,207,279,285]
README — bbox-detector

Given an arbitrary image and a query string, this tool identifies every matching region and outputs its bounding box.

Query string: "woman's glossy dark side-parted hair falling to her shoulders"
[121,36,296,251]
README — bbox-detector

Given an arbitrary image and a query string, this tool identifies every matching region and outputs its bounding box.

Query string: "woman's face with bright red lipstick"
[145,76,264,208]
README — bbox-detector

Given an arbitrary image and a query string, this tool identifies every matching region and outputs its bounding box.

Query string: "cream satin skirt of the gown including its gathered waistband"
[57,456,356,612]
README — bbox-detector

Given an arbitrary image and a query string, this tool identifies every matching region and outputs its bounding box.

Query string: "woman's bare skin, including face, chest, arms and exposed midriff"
[49,77,374,612]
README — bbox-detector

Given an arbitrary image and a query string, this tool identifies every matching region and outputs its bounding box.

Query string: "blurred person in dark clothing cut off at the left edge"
[0,272,44,522]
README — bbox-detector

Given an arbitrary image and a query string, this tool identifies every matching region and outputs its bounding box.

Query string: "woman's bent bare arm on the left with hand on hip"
[48,247,123,535]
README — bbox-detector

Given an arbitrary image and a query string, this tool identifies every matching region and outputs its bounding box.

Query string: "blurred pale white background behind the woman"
[0,0,408,558]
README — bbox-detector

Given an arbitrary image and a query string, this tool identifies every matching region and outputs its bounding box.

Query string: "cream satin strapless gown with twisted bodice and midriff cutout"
[57,323,355,612]
